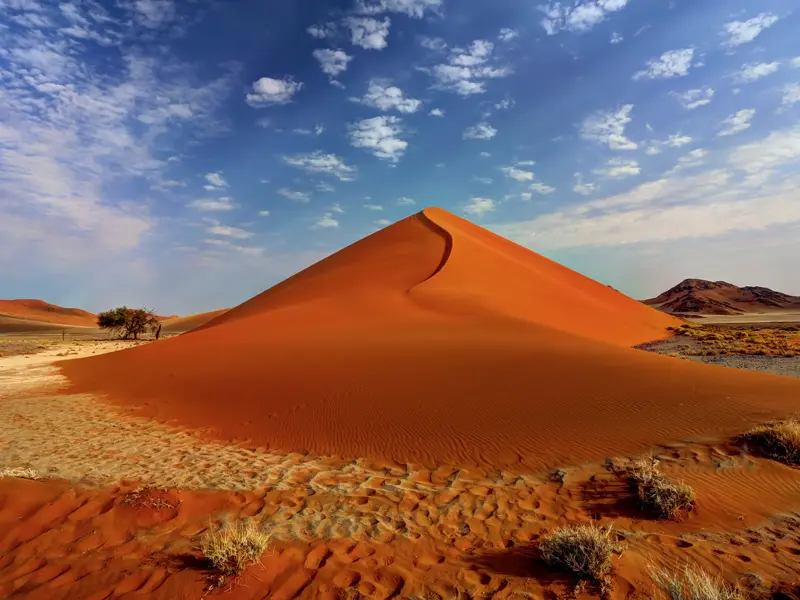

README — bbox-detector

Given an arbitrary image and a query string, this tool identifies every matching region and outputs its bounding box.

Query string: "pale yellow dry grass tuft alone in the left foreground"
[200,521,271,575]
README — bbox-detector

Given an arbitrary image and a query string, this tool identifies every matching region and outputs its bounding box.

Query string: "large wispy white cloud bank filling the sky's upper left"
[0,0,234,264]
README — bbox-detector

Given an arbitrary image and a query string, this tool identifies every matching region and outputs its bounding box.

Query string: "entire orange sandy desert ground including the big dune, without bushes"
[0,208,800,600]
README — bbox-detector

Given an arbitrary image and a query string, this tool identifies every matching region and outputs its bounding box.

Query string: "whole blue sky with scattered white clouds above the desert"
[0,0,800,314]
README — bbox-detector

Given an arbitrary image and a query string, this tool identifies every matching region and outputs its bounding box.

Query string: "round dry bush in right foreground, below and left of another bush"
[539,525,622,581]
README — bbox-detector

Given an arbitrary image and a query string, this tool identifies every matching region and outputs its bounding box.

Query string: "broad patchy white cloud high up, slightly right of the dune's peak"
[422,40,513,96]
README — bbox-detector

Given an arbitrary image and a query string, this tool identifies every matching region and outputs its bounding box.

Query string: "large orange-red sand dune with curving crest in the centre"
[61,208,800,468]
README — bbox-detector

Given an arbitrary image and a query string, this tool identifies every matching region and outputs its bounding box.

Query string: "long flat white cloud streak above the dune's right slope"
[492,159,800,249]
